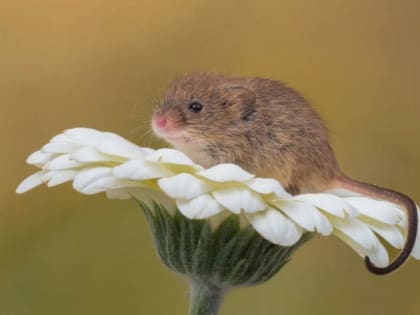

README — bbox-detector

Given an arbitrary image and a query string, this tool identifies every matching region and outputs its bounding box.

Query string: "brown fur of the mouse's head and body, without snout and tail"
[156,73,338,193]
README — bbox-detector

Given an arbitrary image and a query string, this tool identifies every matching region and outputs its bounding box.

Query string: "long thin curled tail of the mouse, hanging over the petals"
[335,176,418,275]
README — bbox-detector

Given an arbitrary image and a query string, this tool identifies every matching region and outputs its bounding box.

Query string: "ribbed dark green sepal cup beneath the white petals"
[138,201,312,289]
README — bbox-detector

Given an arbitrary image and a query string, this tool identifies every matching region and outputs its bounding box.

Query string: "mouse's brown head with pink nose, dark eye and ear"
[152,72,256,150]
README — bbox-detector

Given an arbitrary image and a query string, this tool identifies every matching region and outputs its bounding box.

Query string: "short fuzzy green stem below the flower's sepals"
[189,280,225,315]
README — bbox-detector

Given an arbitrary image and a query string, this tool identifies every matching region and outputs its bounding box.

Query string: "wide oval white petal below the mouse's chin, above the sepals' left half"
[158,173,210,200]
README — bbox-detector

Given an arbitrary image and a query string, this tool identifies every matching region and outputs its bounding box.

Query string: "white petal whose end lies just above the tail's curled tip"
[331,218,379,250]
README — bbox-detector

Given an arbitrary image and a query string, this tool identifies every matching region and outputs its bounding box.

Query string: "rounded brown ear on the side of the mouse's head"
[224,85,257,120]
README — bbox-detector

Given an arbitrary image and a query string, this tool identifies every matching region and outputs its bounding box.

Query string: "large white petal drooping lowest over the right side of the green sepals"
[246,208,302,246]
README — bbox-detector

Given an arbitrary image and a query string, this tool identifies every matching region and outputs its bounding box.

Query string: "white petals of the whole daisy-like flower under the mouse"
[17,128,420,267]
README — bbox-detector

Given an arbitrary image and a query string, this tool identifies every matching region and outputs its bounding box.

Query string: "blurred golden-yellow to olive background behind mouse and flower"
[0,0,420,315]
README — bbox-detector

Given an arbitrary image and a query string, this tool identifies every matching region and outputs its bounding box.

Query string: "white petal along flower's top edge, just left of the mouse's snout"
[96,132,147,159]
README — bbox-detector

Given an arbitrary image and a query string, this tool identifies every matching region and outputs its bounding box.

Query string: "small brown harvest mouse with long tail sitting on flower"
[152,71,418,275]
